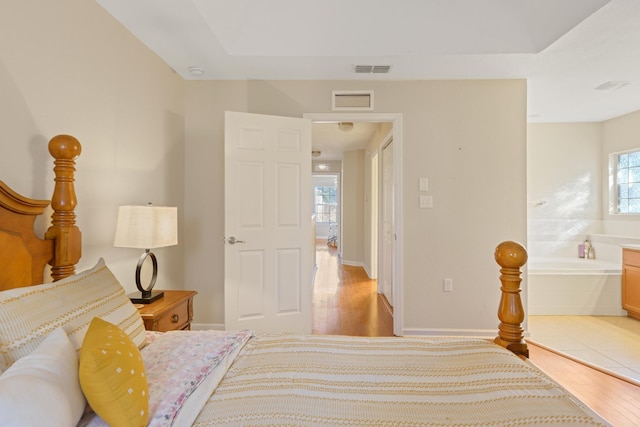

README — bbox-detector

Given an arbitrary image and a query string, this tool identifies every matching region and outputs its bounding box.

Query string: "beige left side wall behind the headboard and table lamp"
[0,0,185,291]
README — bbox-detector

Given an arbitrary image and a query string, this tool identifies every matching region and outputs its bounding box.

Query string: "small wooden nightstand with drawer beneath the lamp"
[137,291,197,332]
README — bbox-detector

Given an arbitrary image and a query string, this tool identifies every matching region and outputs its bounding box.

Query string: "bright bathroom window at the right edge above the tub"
[614,150,640,214]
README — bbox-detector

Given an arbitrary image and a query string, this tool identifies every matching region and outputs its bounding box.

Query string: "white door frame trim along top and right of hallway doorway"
[302,112,404,336]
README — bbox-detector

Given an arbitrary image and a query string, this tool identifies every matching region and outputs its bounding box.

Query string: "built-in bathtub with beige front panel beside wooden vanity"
[527,257,627,316]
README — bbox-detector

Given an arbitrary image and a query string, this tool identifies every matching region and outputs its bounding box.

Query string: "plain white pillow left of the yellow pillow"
[0,328,86,427]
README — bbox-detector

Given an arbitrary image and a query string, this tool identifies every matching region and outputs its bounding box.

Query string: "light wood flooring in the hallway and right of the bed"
[313,242,640,427]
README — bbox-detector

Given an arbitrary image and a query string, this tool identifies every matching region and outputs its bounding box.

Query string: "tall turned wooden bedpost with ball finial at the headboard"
[45,135,82,280]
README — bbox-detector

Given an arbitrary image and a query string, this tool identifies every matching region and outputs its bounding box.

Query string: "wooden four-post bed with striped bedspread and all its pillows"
[0,135,609,426]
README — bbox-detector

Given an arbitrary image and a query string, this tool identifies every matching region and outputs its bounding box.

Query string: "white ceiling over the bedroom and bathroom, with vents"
[96,0,640,159]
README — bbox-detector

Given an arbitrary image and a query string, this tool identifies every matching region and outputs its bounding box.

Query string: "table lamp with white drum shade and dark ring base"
[113,204,178,304]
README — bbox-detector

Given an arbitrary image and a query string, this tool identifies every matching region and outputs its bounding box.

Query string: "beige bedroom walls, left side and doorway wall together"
[0,0,526,333]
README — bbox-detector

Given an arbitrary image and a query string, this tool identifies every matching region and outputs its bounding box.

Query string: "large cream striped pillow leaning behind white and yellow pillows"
[0,258,146,372]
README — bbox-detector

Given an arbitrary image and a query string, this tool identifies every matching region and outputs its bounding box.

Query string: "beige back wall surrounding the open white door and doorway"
[185,80,526,333]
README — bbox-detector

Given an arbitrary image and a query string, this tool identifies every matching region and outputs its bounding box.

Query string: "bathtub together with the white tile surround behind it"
[526,219,640,316]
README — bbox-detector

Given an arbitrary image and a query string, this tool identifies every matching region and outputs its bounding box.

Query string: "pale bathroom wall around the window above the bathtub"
[527,111,640,261]
